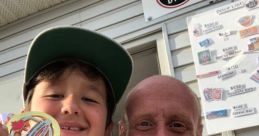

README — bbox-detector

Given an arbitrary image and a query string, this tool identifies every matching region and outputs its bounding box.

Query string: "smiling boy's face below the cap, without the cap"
[30,70,112,136]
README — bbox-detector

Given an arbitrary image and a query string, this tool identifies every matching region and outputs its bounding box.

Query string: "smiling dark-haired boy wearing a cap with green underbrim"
[0,27,132,136]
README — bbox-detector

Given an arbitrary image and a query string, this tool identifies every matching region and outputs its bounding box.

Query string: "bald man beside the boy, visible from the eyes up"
[126,75,202,136]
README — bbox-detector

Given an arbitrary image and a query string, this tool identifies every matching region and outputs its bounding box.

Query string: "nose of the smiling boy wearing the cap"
[61,96,80,115]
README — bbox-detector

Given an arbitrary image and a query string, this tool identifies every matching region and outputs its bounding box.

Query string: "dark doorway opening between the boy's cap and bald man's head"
[113,42,160,136]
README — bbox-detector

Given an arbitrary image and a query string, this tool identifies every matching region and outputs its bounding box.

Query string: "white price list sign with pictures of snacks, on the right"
[187,0,259,134]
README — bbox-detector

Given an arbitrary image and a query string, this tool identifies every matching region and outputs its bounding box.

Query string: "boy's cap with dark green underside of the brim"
[23,27,133,103]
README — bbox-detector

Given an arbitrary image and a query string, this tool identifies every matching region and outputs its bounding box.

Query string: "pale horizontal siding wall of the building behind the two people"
[0,0,259,136]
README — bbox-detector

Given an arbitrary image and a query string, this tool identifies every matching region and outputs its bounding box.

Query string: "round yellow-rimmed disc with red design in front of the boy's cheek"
[7,111,60,136]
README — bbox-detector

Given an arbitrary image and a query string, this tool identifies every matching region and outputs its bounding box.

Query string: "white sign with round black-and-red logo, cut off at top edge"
[142,0,202,21]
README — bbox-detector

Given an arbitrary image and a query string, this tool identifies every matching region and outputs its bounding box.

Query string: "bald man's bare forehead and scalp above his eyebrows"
[128,77,200,114]
